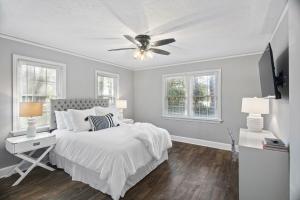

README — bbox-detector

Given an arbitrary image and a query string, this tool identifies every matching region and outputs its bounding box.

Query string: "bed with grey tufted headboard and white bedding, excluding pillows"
[49,99,172,200]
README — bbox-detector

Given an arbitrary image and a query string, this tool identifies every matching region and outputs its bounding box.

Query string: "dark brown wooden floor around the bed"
[0,142,238,200]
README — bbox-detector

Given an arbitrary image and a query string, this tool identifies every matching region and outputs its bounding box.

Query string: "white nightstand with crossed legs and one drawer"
[6,132,56,186]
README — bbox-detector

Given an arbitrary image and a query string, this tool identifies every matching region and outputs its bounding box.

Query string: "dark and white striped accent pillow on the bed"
[87,113,119,131]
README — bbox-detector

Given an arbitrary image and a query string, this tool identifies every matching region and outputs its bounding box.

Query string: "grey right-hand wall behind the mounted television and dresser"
[265,10,290,143]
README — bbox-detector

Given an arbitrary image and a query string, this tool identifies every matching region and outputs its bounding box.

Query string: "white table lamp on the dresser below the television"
[242,97,269,132]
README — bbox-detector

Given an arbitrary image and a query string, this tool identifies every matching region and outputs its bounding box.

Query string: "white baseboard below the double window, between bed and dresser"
[171,135,231,151]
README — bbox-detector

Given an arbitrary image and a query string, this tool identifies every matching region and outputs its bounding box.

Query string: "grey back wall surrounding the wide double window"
[134,55,261,143]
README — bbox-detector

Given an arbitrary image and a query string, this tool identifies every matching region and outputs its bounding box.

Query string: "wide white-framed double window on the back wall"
[163,70,221,121]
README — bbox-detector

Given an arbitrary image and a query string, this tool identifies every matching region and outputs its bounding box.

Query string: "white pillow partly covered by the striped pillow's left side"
[68,108,96,132]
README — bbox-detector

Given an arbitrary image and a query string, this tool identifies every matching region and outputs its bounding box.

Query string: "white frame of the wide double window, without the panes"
[162,69,222,123]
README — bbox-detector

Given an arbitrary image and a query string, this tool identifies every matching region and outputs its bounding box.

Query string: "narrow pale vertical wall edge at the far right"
[289,0,300,200]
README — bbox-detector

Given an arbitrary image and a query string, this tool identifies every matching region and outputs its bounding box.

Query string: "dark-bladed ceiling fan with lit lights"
[108,35,175,60]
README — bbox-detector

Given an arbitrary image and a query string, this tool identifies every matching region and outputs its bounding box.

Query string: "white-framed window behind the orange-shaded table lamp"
[13,55,66,131]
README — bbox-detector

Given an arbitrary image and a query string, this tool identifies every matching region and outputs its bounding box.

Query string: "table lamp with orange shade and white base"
[19,102,43,137]
